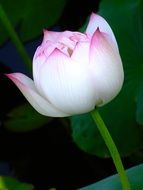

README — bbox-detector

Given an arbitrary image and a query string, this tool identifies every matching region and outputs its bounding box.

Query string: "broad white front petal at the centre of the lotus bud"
[40,49,99,115]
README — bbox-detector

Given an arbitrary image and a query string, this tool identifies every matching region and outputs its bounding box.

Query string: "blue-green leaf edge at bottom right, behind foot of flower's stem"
[81,164,143,190]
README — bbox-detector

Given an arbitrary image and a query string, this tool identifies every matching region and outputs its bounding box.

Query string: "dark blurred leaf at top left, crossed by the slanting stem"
[0,0,66,44]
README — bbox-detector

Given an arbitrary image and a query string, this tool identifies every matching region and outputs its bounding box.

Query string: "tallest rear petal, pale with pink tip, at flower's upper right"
[86,13,118,49]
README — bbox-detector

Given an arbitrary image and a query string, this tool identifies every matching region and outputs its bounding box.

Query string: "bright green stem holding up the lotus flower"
[91,109,131,190]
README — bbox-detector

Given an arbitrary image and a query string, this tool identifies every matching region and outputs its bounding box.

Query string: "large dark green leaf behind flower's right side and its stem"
[71,0,143,157]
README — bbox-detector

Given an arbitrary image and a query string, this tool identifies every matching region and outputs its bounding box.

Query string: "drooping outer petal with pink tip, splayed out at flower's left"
[7,73,68,117]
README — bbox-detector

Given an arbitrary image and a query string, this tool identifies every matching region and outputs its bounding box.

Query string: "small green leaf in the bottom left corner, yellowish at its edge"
[0,176,34,190]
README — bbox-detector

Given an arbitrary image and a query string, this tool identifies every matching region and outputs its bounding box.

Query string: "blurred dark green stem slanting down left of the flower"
[0,5,32,70]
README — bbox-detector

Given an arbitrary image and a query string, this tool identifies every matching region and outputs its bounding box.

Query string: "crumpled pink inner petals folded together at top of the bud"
[34,30,89,60]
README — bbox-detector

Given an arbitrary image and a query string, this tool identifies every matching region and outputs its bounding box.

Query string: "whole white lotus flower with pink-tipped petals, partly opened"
[7,13,124,117]
